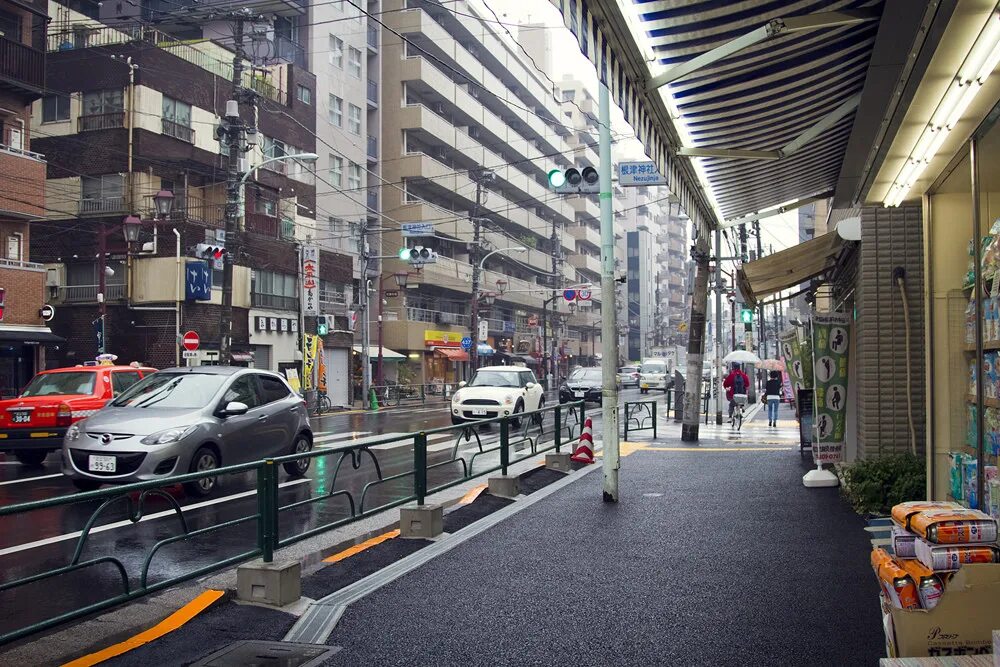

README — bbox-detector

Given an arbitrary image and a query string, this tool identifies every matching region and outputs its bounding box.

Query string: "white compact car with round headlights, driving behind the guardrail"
[451,366,545,425]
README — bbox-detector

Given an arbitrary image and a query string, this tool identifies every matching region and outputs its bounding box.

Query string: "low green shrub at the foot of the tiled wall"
[842,453,927,514]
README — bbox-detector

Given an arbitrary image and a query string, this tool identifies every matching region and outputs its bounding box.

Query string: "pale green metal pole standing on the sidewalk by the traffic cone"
[598,83,621,502]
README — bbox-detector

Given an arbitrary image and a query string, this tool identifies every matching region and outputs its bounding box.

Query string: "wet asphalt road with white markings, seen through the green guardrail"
[0,390,648,634]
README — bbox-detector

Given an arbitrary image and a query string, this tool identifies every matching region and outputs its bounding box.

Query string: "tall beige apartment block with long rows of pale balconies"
[380,0,584,382]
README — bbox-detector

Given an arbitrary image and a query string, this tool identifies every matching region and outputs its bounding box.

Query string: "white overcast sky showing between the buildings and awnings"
[473,0,799,253]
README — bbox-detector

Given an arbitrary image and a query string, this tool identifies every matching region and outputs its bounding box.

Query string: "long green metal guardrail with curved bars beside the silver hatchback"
[0,401,585,645]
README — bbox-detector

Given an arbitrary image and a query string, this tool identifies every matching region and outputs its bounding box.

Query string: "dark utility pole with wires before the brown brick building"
[219,17,246,362]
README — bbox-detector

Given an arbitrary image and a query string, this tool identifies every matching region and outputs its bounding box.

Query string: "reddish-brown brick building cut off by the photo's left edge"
[0,0,50,397]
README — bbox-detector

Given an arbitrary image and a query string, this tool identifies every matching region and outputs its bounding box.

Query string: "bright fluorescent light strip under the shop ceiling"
[882,3,1000,206]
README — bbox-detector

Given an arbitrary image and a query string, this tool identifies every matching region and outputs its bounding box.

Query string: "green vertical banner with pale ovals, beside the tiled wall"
[812,313,851,465]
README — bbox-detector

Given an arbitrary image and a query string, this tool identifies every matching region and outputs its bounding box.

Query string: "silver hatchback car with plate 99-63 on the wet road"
[62,366,312,496]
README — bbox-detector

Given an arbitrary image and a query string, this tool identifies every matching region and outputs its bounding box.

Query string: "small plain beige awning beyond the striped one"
[737,231,844,306]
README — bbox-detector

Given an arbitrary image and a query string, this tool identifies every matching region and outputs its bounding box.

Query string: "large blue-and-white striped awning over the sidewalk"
[551,0,882,222]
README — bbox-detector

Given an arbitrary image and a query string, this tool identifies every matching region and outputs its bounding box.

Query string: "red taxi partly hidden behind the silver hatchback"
[0,366,156,465]
